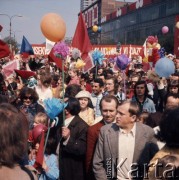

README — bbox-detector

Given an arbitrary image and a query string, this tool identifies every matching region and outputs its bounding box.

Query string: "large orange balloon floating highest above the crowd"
[40,13,66,42]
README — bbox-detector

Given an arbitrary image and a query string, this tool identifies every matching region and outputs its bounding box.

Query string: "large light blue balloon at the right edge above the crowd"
[155,57,175,78]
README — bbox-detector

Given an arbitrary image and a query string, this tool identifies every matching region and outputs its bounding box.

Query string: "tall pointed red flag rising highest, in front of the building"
[72,13,94,72]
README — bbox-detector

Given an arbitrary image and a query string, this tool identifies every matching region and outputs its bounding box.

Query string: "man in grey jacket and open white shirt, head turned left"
[93,102,158,180]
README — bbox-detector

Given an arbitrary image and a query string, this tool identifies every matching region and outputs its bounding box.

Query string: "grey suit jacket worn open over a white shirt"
[93,122,158,180]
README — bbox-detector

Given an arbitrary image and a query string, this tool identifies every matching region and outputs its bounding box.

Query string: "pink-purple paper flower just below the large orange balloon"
[54,42,69,60]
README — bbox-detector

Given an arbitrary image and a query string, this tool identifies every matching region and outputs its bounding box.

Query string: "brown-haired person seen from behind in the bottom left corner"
[0,103,37,180]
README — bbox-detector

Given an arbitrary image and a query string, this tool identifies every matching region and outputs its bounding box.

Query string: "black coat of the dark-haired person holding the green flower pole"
[59,116,88,180]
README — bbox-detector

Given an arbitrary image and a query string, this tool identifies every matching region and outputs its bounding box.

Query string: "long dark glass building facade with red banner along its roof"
[83,0,179,53]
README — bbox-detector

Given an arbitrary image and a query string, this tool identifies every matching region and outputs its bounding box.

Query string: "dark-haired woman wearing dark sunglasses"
[17,87,45,130]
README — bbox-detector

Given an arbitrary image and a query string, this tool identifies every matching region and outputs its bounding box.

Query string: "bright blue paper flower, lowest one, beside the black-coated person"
[44,98,67,119]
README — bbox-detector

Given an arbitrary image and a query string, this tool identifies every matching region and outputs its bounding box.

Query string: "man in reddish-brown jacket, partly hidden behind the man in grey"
[86,95,118,180]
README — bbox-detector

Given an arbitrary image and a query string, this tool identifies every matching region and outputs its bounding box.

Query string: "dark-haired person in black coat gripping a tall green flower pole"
[59,97,88,180]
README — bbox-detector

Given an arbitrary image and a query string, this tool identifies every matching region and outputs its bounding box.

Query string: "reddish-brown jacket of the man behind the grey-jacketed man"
[86,120,105,180]
